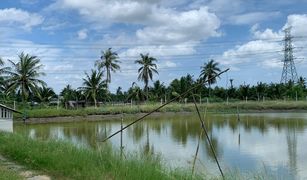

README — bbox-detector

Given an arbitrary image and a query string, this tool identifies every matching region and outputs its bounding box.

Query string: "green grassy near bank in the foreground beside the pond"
[0,132,197,180]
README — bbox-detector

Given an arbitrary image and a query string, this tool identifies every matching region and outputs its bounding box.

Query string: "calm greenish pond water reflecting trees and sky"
[14,113,307,179]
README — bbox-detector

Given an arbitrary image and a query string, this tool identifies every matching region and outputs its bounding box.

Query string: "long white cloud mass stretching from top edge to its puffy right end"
[56,0,220,43]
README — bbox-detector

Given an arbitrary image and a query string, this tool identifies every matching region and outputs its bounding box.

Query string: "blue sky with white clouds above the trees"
[0,0,307,93]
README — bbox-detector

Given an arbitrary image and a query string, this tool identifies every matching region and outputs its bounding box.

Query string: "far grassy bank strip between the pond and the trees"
[15,101,307,119]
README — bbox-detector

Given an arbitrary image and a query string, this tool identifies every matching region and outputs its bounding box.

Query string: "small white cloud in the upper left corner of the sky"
[0,8,44,30]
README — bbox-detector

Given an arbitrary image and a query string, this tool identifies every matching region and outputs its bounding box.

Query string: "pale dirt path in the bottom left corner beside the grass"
[0,155,51,180]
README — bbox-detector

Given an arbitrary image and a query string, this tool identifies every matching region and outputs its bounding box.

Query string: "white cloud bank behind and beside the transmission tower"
[214,14,307,69]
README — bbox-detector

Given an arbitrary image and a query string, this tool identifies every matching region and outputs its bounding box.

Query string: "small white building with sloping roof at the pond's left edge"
[0,104,20,132]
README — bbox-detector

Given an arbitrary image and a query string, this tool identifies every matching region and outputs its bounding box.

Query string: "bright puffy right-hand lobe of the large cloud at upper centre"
[136,7,220,42]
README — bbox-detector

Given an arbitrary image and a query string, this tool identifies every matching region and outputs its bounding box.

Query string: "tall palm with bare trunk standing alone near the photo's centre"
[135,53,159,100]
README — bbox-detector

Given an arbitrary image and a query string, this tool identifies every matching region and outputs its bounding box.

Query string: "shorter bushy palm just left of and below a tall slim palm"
[81,70,106,108]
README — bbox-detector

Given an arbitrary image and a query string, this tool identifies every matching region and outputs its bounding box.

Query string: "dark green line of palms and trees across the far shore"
[0,48,307,107]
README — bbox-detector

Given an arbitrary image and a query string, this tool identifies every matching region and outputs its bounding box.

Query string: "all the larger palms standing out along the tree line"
[0,48,220,107]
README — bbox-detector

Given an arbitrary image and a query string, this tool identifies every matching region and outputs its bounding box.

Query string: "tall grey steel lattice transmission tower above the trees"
[280,27,298,83]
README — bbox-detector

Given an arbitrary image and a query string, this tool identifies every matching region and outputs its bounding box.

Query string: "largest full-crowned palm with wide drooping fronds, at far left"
[6,53,46,102]
